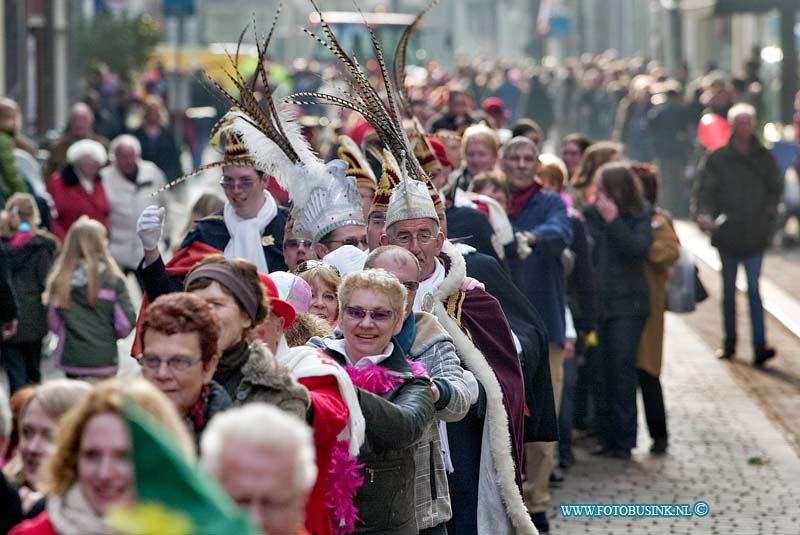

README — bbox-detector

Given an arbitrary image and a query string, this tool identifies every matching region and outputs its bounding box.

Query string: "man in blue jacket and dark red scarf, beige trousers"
[502,136,572,532]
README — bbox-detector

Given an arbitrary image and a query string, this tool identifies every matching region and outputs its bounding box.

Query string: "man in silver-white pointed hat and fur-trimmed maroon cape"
[381,179,535,534]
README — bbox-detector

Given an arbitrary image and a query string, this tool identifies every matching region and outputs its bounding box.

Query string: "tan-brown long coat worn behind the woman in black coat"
[636,210,681,377]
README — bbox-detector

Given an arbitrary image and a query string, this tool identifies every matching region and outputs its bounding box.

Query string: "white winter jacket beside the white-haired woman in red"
[100,160,166,269]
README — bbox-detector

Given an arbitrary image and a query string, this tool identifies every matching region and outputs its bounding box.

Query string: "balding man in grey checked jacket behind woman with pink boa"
[364,245,478,535]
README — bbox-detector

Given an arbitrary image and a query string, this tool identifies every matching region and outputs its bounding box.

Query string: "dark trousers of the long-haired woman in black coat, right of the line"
[595,318,646,451]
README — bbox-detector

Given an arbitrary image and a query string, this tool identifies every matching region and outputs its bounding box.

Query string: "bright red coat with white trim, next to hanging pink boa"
[297,375,349,535]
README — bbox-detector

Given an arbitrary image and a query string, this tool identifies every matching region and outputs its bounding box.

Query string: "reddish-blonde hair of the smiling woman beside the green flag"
[41,378,195,496]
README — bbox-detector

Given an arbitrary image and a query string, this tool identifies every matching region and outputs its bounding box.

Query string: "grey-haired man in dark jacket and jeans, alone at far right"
[692,104,783,366]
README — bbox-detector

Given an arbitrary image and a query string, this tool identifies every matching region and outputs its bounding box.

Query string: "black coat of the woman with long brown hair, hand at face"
[583,205,652,321]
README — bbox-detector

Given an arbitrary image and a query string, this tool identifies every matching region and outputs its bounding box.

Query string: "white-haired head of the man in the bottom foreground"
[200,403,317,535]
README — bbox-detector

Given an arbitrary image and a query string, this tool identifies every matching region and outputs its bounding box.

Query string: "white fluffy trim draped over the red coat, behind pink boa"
[275,336,366,456]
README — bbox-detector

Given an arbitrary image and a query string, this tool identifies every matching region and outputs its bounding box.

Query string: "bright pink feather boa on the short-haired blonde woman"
[325,360,428,535]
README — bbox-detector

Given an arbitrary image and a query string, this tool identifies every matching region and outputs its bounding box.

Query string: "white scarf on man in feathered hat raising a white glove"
[222,191,278,273]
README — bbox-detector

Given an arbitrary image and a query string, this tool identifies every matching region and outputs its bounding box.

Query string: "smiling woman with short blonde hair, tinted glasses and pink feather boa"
[312,269,434,535]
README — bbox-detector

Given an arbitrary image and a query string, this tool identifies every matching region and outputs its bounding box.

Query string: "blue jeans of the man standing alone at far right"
[719,250,764,348]
